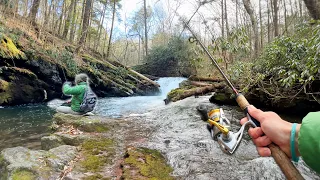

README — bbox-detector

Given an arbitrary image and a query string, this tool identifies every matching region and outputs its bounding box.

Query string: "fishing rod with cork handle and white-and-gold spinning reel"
[180,18,304,180]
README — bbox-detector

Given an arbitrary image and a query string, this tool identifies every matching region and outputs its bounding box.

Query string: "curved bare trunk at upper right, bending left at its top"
[243,0,259,57]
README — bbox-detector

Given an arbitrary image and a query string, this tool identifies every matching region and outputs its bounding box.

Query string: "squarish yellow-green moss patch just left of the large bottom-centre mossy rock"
[81,139,115,172]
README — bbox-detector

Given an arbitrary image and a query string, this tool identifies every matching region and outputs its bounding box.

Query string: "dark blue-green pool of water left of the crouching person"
[0,104,54,151]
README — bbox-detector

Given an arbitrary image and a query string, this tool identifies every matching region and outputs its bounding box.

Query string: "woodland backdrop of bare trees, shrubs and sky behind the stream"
[1,0,320,107]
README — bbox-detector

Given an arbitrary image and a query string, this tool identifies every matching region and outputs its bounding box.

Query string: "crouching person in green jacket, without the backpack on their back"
[56,73,89,114]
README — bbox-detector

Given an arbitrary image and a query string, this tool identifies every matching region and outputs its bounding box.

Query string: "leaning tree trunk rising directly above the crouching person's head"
[76,0,91,53]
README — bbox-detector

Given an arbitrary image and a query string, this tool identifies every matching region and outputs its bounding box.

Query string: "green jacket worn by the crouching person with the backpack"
[62,82,87,112]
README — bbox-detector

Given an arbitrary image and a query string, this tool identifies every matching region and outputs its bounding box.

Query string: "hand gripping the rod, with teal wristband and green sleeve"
[240,106,320,174]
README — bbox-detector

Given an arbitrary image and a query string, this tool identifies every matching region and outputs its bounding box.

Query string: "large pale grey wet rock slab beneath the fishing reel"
[138,96,320,180]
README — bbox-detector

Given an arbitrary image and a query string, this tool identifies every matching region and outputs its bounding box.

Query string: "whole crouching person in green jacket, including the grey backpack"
[56,73,97,115]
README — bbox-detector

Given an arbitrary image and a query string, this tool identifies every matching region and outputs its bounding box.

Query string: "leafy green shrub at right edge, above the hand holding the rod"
[257,24,320,88]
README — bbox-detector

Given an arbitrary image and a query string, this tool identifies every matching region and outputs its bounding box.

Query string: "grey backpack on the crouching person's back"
[80,87,98,113]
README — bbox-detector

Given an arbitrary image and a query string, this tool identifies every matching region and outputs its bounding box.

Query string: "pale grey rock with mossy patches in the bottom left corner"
[0,145,77,179]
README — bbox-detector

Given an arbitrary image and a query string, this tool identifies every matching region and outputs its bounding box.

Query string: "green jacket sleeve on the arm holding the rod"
[298,112,320,174]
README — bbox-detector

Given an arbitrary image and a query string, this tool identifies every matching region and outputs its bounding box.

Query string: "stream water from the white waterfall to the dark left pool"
[0,78,185,151]
